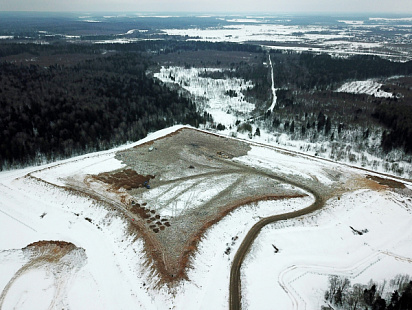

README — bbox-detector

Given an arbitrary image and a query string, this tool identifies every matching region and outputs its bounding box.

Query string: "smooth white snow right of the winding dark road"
[242,190,412,310]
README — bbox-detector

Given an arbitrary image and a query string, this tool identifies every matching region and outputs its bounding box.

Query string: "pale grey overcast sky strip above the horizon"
[0,0,412,14]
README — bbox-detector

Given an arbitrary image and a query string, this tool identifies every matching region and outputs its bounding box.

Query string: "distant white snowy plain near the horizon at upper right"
[163,16,411,61]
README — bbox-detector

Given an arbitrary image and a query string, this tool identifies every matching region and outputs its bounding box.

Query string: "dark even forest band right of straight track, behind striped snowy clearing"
[271,53,412,90]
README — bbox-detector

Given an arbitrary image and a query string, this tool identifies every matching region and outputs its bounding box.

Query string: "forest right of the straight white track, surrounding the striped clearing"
[265,53,412,163]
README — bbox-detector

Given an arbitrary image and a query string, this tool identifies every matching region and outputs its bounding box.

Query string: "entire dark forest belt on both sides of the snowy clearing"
[0,38,412,169]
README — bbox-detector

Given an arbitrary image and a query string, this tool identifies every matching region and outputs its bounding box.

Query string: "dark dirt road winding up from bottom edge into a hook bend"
[229,177,325,310]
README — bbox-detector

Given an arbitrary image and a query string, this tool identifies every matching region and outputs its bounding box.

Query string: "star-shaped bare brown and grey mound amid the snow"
[66,128,382,283]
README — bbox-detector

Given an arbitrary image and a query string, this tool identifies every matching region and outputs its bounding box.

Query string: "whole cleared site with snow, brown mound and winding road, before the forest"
[0,127,412,309]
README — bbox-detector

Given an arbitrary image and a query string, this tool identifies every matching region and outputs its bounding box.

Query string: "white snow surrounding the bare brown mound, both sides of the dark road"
[0,126,412,309]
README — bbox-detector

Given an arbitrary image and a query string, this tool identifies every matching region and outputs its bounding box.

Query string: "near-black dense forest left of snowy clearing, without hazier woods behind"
[0,53,210,169]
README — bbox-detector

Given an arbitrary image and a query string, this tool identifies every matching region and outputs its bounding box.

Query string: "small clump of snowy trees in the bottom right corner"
[322,275,412,310]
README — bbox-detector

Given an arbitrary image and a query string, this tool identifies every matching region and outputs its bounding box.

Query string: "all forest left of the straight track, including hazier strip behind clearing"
[0,40,261,169]
